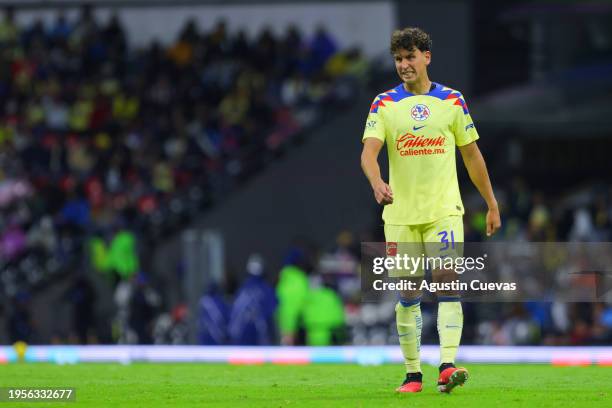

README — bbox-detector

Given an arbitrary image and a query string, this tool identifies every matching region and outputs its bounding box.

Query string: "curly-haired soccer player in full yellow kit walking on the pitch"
[361,27,501,392]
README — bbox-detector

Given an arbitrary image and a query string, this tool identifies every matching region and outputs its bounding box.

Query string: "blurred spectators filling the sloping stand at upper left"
[0,6,368,344]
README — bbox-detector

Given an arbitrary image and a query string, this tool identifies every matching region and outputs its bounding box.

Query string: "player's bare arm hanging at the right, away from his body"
[459,142,501,236]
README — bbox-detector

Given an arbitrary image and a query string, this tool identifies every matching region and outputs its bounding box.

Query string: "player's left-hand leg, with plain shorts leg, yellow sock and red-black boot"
[385,225,423,392]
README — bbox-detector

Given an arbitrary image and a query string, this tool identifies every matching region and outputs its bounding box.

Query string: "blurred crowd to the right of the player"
[465,178,612,345]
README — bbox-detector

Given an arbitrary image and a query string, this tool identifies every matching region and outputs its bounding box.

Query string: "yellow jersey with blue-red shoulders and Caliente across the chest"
[362,82,478,225]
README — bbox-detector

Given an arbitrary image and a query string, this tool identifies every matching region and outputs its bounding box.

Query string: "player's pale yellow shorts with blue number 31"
[385,215,463,277]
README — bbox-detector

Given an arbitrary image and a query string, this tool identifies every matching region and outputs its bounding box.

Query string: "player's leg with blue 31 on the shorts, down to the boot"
[424,216,468,392]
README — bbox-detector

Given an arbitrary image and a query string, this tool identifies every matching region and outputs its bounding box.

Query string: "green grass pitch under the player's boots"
[0,363,612,408]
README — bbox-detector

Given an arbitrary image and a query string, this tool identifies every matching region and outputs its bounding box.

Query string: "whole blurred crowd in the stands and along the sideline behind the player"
[0,7,612,345]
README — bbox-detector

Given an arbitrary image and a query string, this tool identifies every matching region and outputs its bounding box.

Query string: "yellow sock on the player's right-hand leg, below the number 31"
[438,301,463,364]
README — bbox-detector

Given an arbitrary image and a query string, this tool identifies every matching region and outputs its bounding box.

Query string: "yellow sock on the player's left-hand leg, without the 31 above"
[395,301,423,373]
